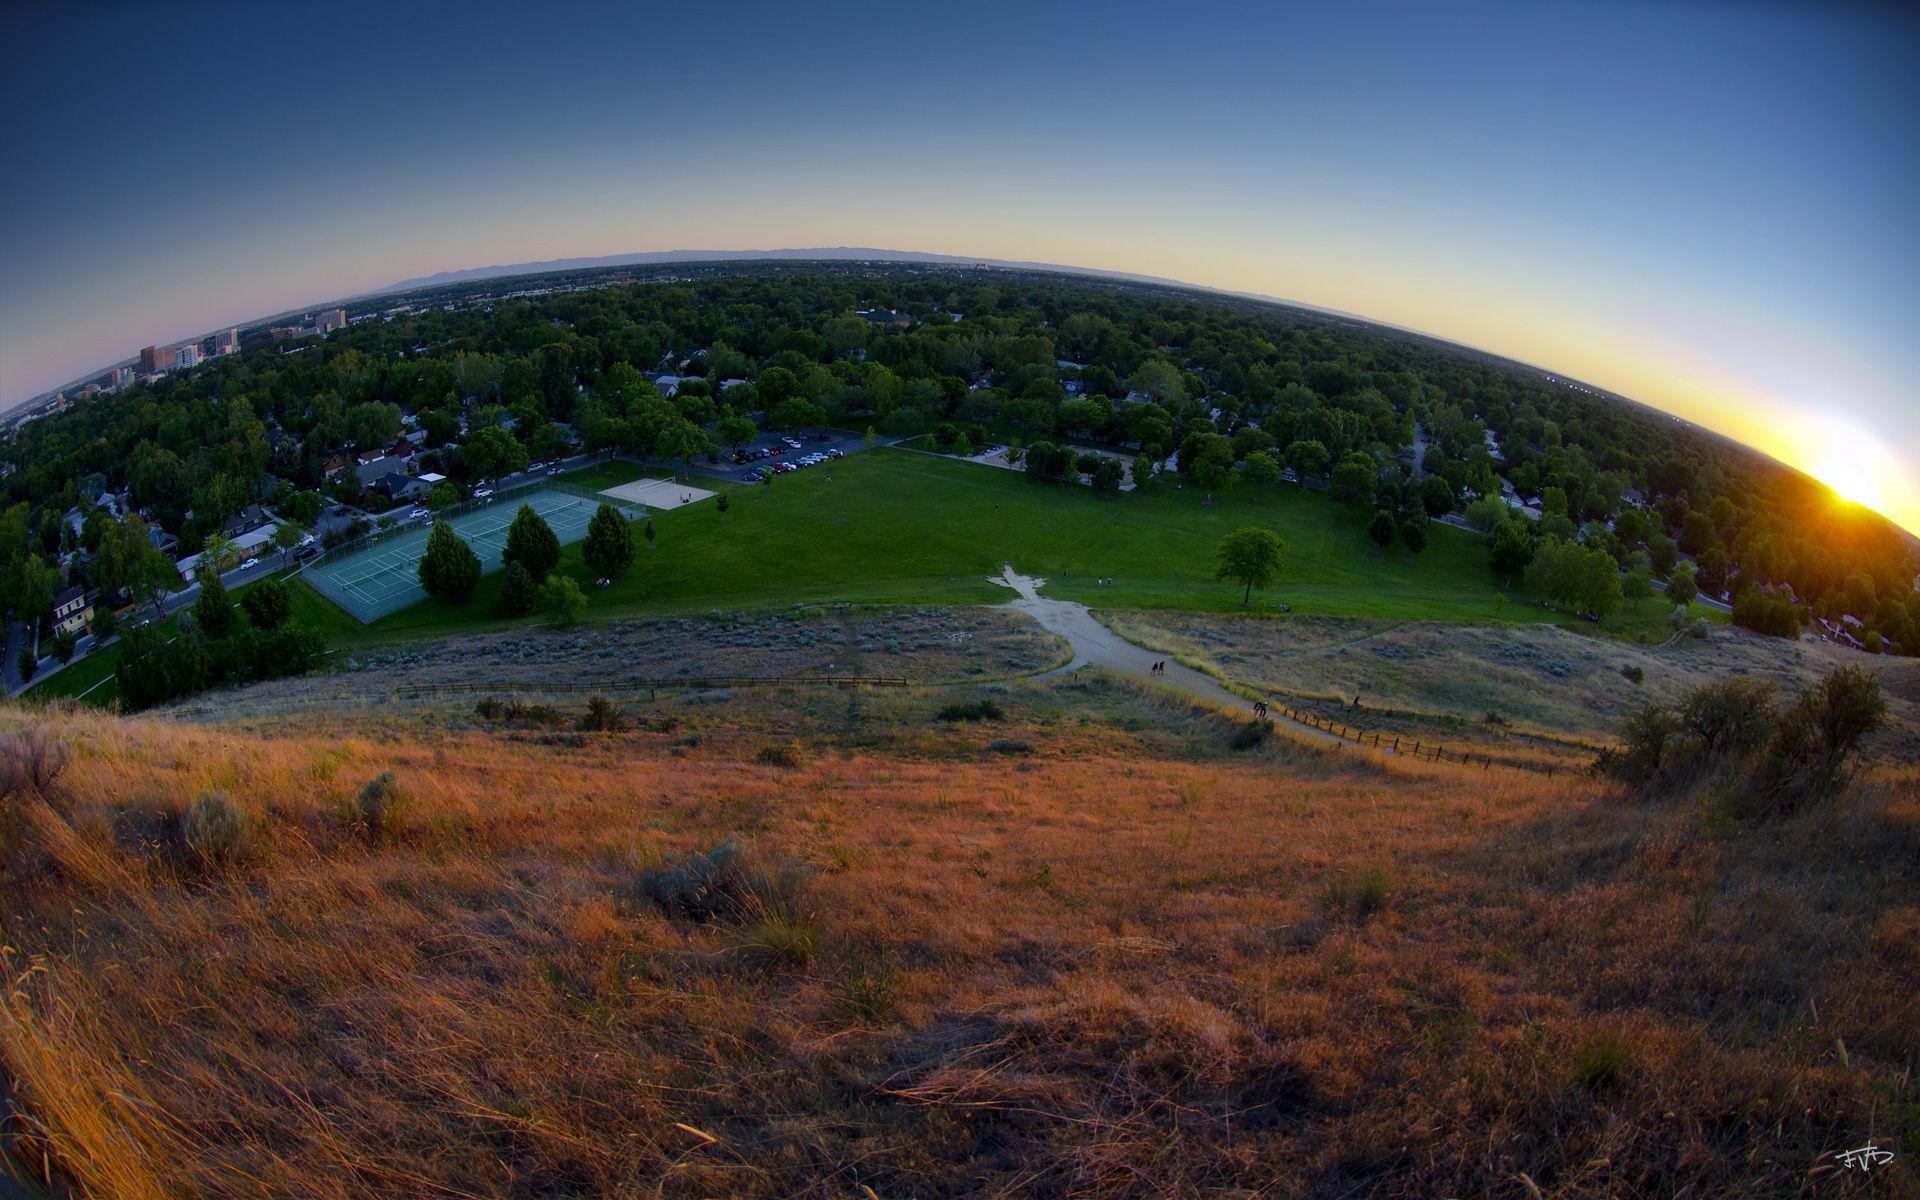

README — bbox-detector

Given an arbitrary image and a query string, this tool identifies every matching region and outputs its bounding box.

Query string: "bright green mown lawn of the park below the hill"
[353,441,1697,641]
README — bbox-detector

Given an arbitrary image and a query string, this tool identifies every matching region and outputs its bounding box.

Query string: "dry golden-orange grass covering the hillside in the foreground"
[0,684,1920,1198]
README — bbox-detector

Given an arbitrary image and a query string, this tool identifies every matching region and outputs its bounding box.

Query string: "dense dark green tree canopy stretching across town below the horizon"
[0,263,1920,653]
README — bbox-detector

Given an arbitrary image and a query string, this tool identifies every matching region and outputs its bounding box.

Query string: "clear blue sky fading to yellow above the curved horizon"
[0,0,1920,530]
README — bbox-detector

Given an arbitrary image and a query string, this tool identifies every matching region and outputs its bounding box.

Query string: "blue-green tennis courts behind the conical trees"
[305,488,634,622]
